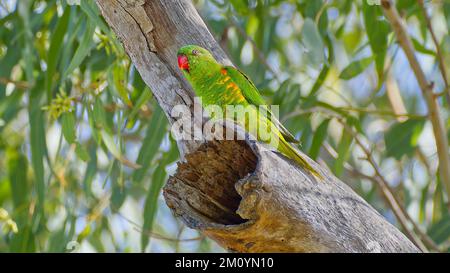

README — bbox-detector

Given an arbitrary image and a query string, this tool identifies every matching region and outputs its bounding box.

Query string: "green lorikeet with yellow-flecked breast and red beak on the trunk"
[177,45,321,178]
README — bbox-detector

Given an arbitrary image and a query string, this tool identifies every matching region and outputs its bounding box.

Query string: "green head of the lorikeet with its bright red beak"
[177,45,217,77]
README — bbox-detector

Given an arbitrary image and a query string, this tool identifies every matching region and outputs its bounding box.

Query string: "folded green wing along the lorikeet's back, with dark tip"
[224,66,299,143]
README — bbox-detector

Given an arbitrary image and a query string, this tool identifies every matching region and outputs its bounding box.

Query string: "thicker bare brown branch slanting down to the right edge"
[381,0,450,200]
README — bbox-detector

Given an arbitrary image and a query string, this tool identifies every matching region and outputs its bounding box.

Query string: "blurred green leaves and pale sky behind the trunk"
[0,0,450,252]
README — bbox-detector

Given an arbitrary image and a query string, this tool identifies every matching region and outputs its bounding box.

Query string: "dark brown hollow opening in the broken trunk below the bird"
[164,140,257,225]
